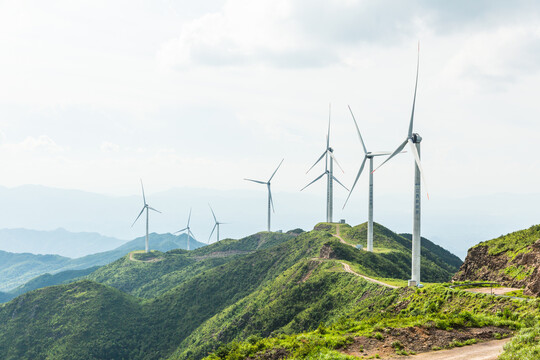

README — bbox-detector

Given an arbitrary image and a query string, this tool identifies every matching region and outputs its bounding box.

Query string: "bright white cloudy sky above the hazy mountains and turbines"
[0,0,540,253]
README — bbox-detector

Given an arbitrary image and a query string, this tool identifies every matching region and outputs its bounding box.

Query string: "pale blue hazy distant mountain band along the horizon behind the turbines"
[0,186,540,259]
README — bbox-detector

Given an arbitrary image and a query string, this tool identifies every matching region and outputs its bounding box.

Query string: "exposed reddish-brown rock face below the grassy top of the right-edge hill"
[452,239,540,296]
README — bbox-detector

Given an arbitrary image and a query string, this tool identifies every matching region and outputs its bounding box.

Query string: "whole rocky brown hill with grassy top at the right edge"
[453,225,540,296]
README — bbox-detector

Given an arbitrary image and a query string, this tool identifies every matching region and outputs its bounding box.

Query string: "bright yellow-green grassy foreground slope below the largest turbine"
[204,285,540,360]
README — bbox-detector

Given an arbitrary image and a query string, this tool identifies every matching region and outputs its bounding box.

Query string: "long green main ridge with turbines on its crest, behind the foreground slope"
[0,224,476,359]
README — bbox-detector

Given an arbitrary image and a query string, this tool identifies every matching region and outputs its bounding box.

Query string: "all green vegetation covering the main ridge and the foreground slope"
[0,223,528,360]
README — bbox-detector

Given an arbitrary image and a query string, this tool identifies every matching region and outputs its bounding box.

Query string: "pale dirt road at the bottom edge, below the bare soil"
[389,339,510,360]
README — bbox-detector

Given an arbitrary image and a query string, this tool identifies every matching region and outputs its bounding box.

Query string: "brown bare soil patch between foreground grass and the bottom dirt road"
[342,326,512,359]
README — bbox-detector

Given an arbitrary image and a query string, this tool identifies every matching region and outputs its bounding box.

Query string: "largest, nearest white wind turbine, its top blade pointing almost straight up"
[373,44,429,286]
